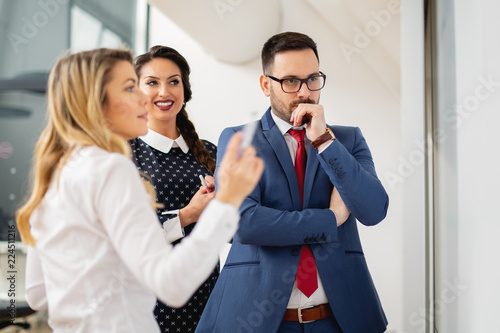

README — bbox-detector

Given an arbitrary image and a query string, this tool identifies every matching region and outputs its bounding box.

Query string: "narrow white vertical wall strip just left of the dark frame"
[400,0,430,333]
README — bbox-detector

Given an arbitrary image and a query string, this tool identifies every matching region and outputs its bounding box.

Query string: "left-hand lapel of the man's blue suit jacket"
[261,108,300,210]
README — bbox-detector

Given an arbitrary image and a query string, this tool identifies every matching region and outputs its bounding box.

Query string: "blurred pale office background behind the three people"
[0,0,500,333]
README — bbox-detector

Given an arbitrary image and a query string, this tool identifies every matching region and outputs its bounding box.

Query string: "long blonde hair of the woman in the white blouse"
[16,49,155,246]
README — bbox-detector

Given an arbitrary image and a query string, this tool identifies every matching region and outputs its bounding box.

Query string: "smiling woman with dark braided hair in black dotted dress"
[131,45,219,332]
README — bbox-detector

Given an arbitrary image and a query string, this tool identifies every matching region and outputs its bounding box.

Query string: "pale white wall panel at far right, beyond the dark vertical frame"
[435,0,500,333]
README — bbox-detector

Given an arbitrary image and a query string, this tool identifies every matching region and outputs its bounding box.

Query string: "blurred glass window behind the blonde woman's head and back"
[0,0,142,241]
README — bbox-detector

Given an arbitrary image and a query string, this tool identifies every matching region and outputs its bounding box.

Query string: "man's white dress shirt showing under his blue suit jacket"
[271,112,328,309]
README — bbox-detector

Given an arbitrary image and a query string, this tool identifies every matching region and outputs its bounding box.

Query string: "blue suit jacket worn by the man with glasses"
[196,109,388,333]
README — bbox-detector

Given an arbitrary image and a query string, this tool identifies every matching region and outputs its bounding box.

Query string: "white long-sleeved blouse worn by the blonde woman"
[26,146,239,333]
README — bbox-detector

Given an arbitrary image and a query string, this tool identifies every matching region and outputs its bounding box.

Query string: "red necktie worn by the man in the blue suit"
[288,129,318,297]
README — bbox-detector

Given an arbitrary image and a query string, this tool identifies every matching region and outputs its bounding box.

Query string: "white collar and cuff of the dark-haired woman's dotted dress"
[139,129,189,243]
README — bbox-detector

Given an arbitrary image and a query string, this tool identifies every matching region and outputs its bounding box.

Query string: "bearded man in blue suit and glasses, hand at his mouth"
[196,32,388,333]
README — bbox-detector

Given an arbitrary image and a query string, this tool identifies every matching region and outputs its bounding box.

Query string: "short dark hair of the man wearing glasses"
[261,31,319,74]
